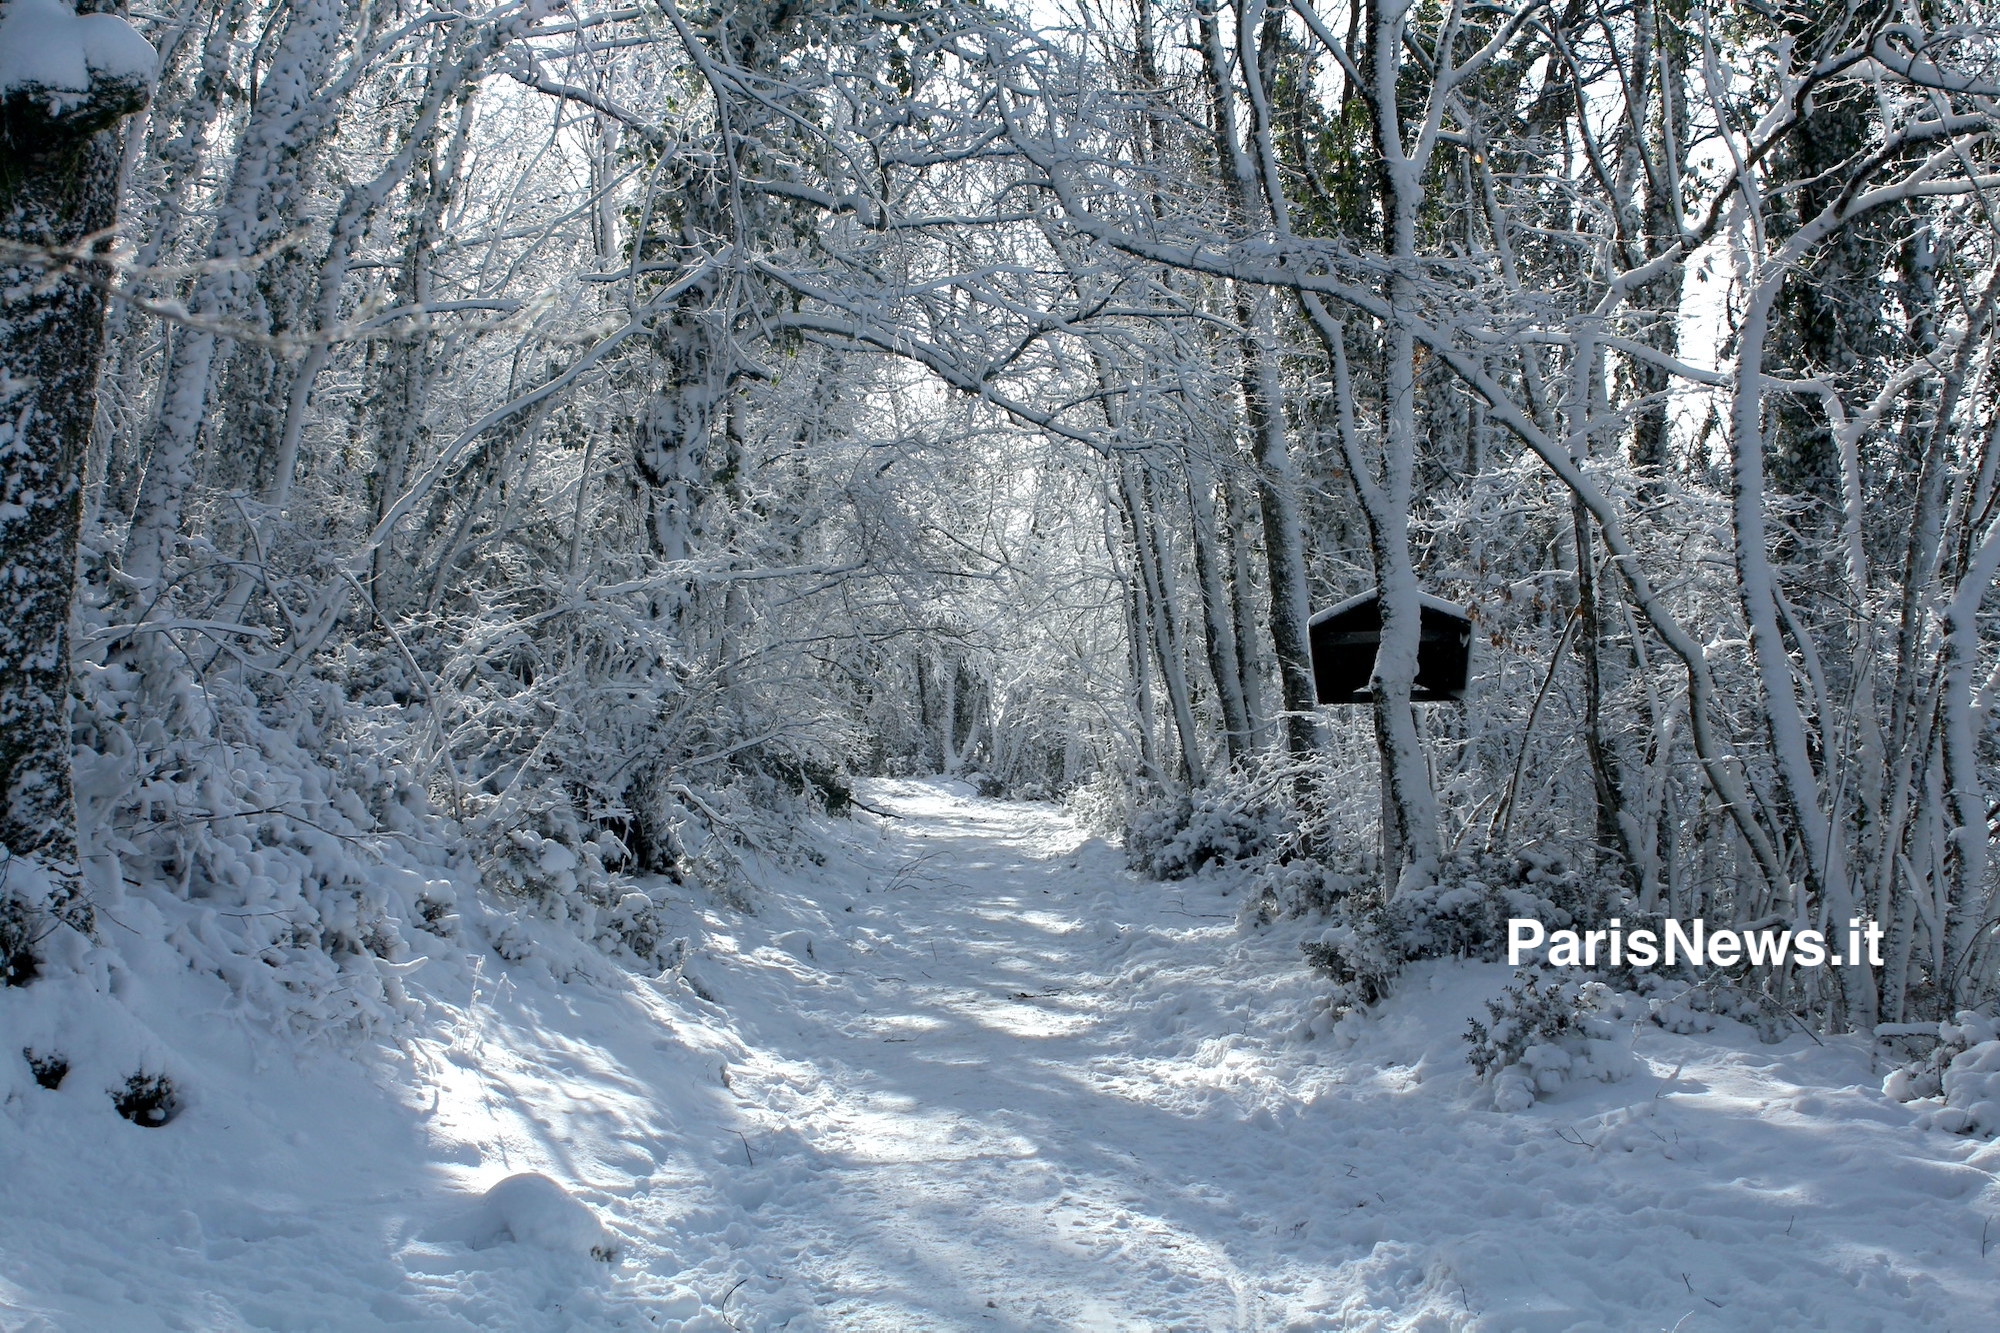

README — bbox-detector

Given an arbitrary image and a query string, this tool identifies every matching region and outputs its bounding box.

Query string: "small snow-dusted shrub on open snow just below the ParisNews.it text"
[1466,969,1638,1111]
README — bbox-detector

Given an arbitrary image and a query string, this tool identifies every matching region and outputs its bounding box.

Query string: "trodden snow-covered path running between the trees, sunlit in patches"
[692,783,1304,1329]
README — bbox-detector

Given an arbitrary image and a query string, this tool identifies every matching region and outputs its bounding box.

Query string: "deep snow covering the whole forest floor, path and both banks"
[0,781,2000,1333]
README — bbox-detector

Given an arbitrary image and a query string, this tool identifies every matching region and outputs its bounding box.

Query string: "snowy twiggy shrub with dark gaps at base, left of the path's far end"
[434,550,866,880]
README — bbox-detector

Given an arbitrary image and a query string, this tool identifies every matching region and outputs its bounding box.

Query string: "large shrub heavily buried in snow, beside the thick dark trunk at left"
[76,628,470,1037]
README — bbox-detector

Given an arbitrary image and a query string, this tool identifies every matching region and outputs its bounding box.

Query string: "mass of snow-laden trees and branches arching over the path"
[11,0,2000,1031]
